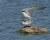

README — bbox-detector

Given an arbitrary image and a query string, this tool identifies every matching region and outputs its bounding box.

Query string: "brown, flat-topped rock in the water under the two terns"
[22,26,48,33]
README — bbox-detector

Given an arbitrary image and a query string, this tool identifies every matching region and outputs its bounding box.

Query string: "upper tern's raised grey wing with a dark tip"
[24,6,46,16]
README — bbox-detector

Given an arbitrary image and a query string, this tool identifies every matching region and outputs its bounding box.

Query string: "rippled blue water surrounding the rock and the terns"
[0,0,50,40]
